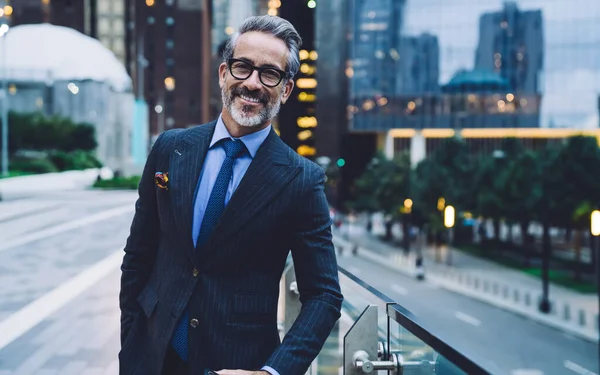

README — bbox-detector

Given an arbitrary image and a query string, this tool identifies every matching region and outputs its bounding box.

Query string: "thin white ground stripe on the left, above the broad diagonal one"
[0,204,133,252]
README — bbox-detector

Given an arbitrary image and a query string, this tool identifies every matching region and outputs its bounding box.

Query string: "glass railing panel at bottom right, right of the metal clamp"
[388,304,500,375]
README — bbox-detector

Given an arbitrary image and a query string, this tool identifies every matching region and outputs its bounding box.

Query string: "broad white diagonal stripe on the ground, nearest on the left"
[0,250,123,350]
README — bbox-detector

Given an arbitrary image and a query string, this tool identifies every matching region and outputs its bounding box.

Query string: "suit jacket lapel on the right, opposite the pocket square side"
[206,130,300,256]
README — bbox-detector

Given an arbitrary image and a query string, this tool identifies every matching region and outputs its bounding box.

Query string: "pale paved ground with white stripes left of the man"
[0,191,137,375]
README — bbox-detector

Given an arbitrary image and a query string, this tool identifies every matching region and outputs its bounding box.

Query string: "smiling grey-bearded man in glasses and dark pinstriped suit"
[119,16,342,375]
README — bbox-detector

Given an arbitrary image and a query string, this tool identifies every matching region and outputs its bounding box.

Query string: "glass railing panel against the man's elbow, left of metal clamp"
[309,268,391,375]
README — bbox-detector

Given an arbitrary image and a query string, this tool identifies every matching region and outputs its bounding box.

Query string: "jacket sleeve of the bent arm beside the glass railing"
[265,164,343,375]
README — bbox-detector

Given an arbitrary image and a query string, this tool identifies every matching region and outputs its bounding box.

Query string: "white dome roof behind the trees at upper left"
[0,24,131,92]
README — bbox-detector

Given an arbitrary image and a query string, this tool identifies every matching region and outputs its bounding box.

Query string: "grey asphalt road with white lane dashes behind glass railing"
[338,255,598,375]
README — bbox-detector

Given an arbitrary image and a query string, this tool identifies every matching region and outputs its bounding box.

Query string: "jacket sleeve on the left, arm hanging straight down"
[119,133,166,345]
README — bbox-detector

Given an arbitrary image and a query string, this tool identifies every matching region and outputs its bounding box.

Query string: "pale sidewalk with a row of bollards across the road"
[334,225,598,341]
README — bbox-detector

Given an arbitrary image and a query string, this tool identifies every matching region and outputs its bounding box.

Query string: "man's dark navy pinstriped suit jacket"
[119,122,342,375]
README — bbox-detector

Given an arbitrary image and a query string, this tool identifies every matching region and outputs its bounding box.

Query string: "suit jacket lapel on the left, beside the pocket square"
[169,122,216,260]
